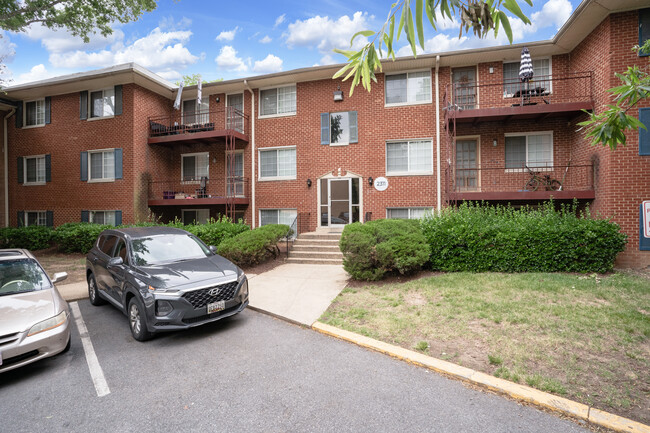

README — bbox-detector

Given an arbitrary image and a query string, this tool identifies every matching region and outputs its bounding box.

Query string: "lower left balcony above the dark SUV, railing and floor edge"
[148,177,250,206]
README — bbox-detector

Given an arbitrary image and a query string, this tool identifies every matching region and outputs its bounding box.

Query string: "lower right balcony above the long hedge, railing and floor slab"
[445,162,595,201]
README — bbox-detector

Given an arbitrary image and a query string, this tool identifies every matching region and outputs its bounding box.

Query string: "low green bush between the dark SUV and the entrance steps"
[217,224,291,266]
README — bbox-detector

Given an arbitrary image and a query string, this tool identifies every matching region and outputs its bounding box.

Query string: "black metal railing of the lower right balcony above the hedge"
[446,163,594,193]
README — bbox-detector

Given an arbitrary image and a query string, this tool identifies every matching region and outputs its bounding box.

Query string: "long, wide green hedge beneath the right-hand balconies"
[421,202,627,272]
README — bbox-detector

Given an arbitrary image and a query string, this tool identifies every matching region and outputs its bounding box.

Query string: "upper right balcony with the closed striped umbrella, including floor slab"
[444,72,593,124]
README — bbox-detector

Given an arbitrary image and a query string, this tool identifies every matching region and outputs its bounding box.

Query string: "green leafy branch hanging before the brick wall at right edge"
[578,40,650,150]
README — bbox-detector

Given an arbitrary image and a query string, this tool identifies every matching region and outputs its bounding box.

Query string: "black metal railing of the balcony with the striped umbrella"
[446,71,593,110]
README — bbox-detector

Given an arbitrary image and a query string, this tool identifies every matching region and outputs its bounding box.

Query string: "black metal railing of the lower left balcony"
[149,176,250,204]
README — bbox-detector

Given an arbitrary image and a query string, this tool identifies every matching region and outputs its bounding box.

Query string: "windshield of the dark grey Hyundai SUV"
[131,235,210,266]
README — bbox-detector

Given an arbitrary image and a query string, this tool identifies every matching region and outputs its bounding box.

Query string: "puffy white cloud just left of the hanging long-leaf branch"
[284,12,373,55]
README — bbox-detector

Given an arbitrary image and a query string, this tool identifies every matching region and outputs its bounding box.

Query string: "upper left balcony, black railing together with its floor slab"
[148,107,250,144]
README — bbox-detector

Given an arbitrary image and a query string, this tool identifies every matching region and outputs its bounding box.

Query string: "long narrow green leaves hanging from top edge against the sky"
[332,0,533,96]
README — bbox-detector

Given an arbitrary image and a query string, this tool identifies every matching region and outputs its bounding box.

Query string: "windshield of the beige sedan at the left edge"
[0,259,50,296]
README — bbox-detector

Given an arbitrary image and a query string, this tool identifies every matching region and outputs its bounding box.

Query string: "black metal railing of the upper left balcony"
[149,107,250,138]
